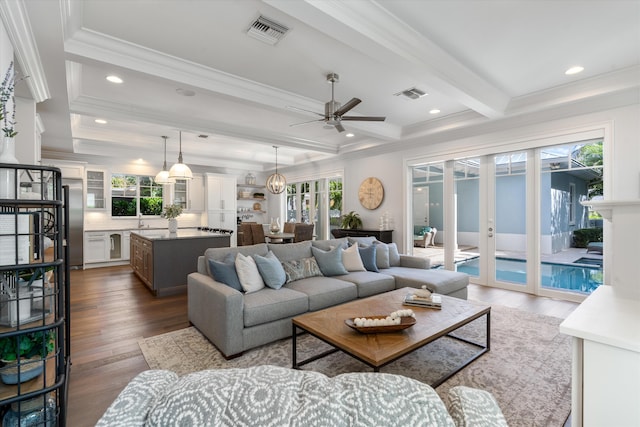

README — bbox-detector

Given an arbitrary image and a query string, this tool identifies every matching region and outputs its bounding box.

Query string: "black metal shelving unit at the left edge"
[0,164,70,426]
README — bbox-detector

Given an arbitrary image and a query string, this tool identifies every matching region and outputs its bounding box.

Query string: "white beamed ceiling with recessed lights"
[8,0,640,171]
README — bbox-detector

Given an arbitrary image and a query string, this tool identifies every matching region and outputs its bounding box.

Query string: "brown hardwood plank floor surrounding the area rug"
[67,266,578,427]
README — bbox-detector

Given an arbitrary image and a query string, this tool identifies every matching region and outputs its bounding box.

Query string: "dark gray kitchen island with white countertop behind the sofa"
[130,229,230,296]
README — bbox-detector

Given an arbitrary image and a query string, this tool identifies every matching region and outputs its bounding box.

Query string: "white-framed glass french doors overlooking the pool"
[410,138,604,301]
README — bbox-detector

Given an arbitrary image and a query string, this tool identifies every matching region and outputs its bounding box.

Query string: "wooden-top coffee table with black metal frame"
[292,288,491,387]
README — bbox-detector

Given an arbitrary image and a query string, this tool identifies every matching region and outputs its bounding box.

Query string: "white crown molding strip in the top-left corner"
[0,0,51,103]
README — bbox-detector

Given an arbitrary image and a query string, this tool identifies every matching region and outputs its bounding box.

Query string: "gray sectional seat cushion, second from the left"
[283,277,358,311]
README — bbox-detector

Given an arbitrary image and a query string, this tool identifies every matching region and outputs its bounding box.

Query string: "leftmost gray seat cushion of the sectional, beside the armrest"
[243,287,309,327]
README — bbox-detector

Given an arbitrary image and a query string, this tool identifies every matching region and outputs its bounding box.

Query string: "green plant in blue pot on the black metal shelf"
[0,330,55,384]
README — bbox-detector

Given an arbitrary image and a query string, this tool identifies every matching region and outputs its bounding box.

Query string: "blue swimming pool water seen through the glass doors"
[456,258,603,294]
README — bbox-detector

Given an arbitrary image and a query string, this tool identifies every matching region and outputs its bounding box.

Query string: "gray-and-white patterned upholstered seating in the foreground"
[96,365,507,427]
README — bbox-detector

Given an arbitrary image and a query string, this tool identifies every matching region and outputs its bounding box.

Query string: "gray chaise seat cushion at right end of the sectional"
[381,267,469,295]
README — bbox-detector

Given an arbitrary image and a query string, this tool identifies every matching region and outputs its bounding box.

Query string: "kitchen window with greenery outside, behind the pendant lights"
[111,174,162,217]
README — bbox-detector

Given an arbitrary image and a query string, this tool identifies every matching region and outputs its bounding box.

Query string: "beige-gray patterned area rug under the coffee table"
[139,305,571,427]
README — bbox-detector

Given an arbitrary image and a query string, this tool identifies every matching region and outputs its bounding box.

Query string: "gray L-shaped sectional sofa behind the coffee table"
[187,237,469,358]
